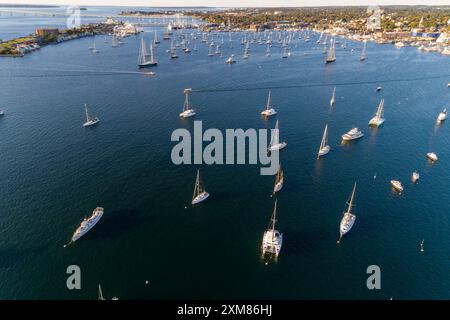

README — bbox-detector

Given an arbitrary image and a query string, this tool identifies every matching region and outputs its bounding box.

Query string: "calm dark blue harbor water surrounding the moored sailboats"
[0,8,450,299]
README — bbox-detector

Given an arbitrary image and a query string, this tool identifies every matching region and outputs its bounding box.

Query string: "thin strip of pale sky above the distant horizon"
[0,0,450,7]
